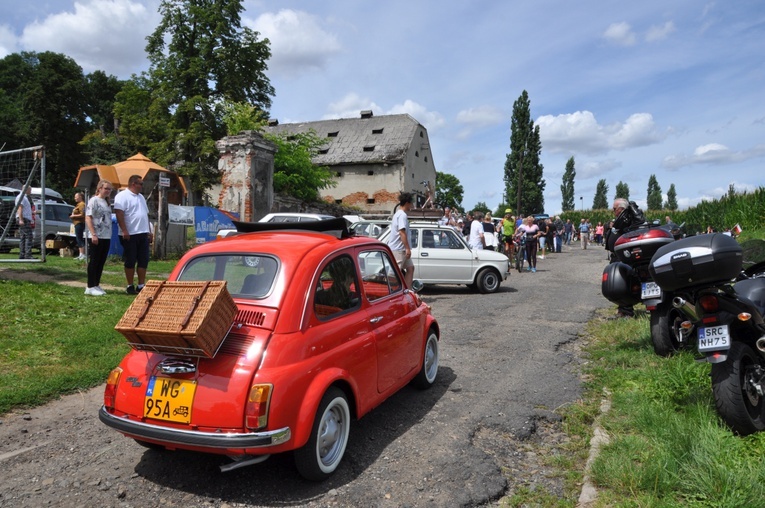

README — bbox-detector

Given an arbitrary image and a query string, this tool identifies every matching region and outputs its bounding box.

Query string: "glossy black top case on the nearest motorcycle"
[648,233,743,291]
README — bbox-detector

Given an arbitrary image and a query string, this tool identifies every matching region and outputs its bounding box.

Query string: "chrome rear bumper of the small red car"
[98,406,292,448]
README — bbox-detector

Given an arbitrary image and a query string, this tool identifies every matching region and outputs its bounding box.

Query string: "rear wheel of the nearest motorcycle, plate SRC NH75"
[712,341,765,436]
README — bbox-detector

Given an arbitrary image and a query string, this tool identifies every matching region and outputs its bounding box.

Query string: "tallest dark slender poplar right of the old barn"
[504,90,545,215]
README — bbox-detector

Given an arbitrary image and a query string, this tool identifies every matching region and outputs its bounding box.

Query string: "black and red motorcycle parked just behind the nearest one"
[601,221,692,356]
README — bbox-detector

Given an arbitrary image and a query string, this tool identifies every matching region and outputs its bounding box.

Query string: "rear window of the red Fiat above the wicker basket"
[178,254,279,299]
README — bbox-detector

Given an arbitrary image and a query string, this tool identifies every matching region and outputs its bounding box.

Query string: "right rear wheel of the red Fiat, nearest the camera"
[295,387,351,481]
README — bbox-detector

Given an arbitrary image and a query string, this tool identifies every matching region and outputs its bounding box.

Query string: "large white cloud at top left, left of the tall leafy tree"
[19,0,152,77]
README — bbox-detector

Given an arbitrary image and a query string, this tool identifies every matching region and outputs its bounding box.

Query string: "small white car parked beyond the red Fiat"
[379,222,510,293]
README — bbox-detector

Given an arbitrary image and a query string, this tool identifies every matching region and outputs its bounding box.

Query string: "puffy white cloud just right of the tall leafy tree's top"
[251,9,342,77]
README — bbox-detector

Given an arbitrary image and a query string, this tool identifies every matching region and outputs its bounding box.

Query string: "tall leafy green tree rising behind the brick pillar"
[119,0,274,197]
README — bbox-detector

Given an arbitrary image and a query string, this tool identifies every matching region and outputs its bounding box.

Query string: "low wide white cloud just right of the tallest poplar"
[537,111,666,155]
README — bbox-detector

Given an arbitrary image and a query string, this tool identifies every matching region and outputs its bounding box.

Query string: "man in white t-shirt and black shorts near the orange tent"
[114,175,152,295]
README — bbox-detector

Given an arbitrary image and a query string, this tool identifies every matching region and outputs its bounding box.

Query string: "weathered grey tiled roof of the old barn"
[266,114,418,166]
